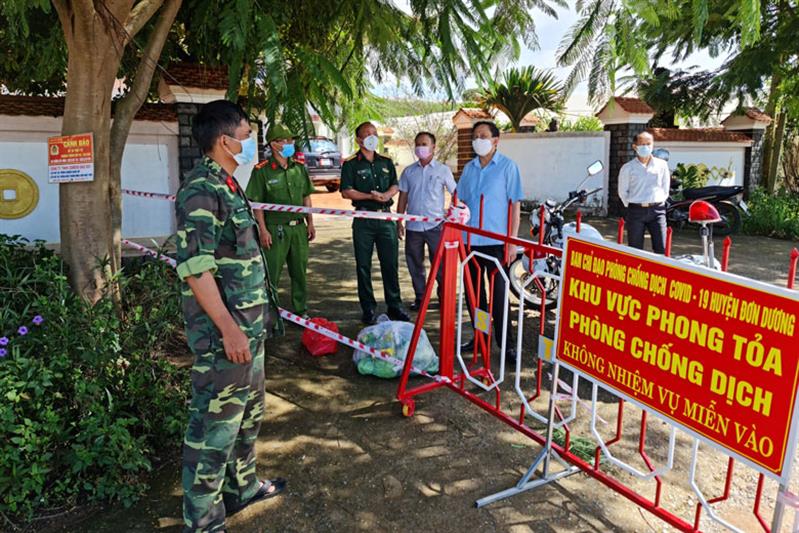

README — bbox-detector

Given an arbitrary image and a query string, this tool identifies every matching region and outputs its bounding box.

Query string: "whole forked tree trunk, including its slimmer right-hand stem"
[53,0,181,302]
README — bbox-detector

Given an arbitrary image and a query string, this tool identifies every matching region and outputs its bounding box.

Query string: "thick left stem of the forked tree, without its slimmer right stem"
[55,2,124,302]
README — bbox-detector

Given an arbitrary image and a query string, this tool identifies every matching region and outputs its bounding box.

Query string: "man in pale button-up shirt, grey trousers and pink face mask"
[397,131,455,311]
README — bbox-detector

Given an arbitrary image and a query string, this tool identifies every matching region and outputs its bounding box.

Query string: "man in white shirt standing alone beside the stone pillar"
[619,131,671,254]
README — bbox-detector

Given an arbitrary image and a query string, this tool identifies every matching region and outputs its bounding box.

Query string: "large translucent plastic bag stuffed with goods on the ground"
[352,315,438,379]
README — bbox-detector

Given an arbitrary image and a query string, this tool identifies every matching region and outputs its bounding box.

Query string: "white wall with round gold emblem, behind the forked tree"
[0,116,178,243]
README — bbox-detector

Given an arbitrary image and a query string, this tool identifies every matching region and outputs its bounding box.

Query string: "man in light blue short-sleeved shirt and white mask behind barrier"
[457,121,524,360]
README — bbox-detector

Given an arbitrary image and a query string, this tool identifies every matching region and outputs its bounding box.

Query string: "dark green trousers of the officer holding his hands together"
[352,218,402,313]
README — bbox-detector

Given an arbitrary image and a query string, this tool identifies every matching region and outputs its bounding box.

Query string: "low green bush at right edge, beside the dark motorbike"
[744,189,799,240]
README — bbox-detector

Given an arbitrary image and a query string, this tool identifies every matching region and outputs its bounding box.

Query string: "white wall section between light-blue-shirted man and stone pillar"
[499,131,610,212]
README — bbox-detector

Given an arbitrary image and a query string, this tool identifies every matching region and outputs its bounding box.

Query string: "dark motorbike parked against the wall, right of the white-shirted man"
[652,148,749,236]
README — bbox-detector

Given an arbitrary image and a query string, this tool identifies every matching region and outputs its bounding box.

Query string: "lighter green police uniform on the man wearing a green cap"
[247,157,314,315]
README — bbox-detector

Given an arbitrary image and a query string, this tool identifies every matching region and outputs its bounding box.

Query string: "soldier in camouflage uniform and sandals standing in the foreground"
[175,100,285,533]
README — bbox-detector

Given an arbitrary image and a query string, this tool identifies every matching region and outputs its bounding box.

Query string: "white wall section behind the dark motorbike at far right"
[656,141,746,185]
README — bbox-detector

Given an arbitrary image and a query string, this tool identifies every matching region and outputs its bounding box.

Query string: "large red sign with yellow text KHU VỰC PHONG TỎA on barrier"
[556,238,799,478]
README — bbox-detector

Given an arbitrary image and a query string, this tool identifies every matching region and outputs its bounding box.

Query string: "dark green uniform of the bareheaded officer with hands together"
[341,151,402,314]
